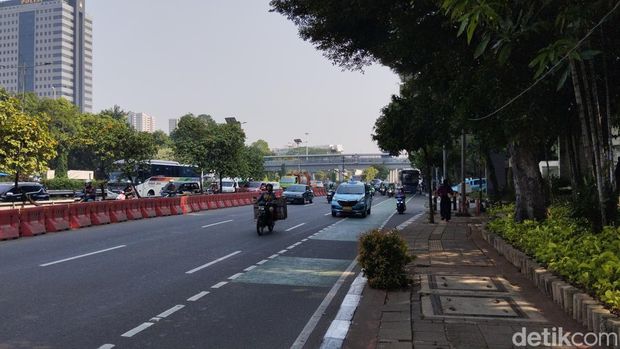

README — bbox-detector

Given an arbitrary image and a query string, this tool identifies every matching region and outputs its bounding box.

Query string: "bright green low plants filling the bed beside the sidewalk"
[487,205,620,311]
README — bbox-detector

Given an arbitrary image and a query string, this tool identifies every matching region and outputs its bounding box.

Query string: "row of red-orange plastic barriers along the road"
[0,188,325,240]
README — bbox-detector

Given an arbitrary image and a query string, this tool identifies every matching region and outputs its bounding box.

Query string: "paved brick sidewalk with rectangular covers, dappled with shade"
[343,216,604,349]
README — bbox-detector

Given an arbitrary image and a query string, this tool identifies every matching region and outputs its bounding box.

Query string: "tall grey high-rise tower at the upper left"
[0,0,93,112]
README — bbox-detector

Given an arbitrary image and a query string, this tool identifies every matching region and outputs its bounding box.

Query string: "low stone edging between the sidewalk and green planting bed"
[476,227,620,349]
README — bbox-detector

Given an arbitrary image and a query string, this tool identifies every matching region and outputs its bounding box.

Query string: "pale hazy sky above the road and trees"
[86,0,399,153]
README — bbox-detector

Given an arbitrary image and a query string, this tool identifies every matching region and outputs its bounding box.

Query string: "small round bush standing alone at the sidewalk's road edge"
[358,229,413,289]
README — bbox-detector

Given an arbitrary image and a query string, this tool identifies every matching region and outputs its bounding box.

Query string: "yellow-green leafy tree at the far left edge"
[0,90,56,186]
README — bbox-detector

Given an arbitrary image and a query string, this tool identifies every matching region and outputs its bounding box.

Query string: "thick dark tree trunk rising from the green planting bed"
[508,140,546,222]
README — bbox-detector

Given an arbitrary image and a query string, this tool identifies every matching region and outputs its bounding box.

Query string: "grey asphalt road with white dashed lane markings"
[0,195,423,349]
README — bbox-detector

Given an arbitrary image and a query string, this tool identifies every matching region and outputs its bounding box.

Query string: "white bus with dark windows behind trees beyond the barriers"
[108,160,201,197]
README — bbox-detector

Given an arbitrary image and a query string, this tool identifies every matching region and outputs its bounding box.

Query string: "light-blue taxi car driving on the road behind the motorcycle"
[331,181,372,217]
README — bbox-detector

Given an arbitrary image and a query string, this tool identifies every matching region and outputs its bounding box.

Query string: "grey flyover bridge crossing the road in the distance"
[264,153,411,172]
